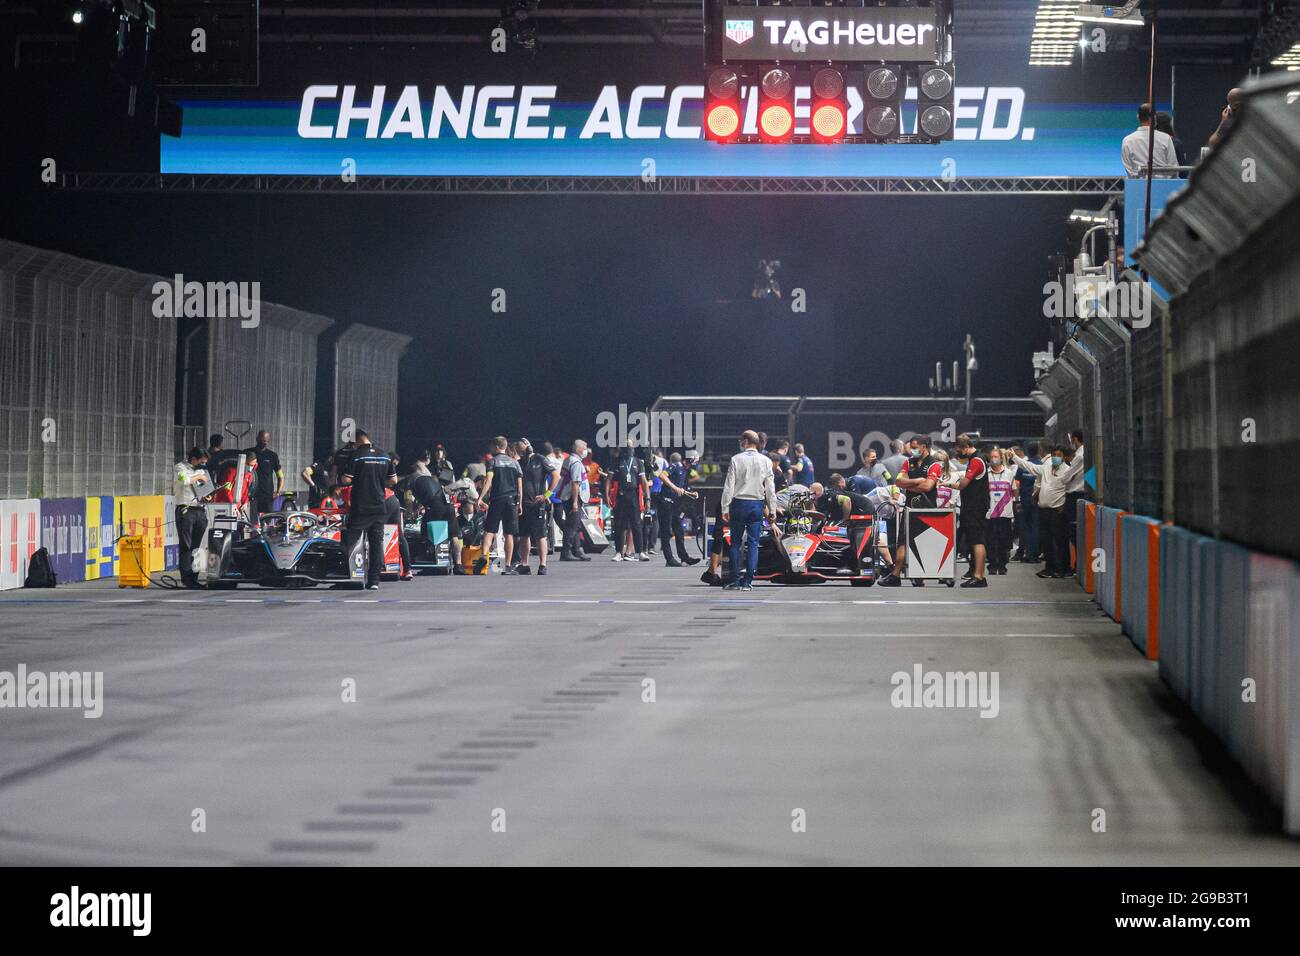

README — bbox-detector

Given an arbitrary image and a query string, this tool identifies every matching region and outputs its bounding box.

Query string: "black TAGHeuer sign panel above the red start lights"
[722,7,943,62]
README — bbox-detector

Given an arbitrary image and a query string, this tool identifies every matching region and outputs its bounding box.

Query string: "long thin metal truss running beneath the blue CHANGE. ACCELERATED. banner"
[52,173,1125,196]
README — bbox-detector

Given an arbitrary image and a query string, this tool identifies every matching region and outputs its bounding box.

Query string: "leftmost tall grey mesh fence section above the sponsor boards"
[0,241,176,498]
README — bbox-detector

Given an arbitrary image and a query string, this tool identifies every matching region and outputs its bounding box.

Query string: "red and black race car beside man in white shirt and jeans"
[722,490,883,588]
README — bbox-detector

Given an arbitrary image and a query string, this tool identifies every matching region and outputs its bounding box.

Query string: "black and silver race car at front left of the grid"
[205,511,402,588]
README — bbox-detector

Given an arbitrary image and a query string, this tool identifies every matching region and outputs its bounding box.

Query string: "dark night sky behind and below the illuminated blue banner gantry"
[0,14,1196,463]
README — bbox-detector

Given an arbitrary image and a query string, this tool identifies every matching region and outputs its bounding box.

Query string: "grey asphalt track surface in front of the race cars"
[0,558,1300,865]
